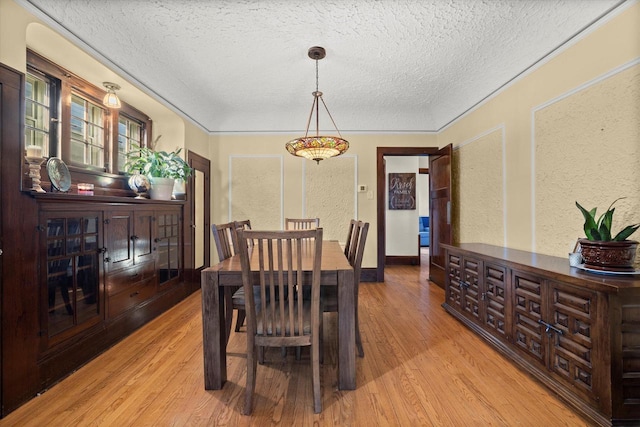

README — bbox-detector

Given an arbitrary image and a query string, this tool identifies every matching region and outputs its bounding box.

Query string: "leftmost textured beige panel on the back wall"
[229,156,283,230]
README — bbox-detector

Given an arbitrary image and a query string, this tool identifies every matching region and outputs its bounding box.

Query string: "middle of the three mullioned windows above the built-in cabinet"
[70,93,105,168]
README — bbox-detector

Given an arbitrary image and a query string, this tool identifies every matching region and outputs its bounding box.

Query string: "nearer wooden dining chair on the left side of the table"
[211,221,245,342]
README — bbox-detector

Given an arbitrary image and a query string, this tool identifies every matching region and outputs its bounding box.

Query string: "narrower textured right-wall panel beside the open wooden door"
[452,129,505,245]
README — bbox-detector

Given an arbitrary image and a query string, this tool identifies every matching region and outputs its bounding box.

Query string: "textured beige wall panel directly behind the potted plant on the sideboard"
[533,65,640,254]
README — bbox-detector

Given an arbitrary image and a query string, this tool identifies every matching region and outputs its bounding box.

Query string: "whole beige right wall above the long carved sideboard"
[438,2,640,257]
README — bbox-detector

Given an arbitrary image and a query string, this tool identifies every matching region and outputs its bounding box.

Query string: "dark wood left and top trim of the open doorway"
[376,147,440,282]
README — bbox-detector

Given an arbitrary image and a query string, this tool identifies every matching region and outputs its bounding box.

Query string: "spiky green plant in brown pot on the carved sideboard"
[576,197,640,271]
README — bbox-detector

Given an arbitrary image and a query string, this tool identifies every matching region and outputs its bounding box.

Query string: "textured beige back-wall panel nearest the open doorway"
[303,155,358,243]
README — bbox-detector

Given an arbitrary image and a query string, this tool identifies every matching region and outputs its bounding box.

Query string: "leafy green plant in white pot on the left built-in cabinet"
[124,145,192,200]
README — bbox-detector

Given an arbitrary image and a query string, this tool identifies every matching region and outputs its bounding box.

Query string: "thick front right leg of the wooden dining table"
[338,270,356,390]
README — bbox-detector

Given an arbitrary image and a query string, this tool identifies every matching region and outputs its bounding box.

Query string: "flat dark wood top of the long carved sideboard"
[442,243,640,292]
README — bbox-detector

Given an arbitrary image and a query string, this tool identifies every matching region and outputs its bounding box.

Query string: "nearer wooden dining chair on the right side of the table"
[322,221,369,357]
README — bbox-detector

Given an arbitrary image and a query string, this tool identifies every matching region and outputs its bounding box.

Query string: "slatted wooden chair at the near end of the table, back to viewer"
[238,228,322,415]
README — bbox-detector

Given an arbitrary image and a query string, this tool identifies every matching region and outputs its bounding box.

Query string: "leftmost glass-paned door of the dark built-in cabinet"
[43,213,102,338]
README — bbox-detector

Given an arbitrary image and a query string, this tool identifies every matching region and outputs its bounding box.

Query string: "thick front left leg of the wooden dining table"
[201,271,227,390]
